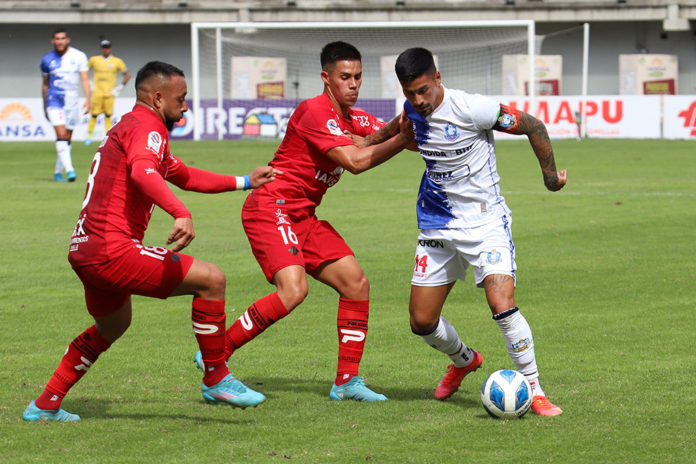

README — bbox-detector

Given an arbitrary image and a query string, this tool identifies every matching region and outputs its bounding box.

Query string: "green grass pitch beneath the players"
[0,140,696,464]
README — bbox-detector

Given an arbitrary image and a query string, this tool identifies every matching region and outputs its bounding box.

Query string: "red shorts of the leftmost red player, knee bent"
[73,242,193,317]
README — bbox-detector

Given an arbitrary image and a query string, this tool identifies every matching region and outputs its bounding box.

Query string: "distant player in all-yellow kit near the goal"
[85,39,130,145]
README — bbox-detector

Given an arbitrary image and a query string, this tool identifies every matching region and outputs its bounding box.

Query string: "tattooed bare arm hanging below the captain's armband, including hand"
[512,111,567,192]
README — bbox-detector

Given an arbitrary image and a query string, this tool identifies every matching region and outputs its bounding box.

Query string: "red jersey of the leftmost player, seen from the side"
[68,105,191,267]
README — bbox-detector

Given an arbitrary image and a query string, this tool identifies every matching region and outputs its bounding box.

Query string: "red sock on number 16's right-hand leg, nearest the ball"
[335,298,370,385]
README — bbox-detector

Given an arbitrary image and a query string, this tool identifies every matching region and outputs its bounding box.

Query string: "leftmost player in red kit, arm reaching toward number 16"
[23,61,280,421]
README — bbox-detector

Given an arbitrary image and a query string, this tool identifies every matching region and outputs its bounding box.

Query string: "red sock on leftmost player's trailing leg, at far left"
[35,326,110,410]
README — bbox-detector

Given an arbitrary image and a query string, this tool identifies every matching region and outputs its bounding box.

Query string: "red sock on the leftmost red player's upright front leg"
[191,297,230,387]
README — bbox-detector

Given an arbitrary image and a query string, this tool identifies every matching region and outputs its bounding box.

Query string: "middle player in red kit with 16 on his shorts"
[196,42,413,401]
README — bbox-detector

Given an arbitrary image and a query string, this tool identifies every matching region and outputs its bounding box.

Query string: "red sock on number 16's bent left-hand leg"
[225,292,290,359]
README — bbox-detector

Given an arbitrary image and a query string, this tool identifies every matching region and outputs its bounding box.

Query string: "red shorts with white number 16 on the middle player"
[242,194,354,282]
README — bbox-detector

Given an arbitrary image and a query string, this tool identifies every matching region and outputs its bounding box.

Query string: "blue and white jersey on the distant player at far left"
[41,47,88,108]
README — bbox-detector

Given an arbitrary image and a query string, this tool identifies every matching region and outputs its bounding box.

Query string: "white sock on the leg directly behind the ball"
[493,307,546,396]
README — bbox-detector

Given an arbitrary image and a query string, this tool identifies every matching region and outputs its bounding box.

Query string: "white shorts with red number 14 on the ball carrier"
[411,215,517,287]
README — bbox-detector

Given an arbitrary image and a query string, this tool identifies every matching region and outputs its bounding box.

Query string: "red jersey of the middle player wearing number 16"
[252,93,384,209]
